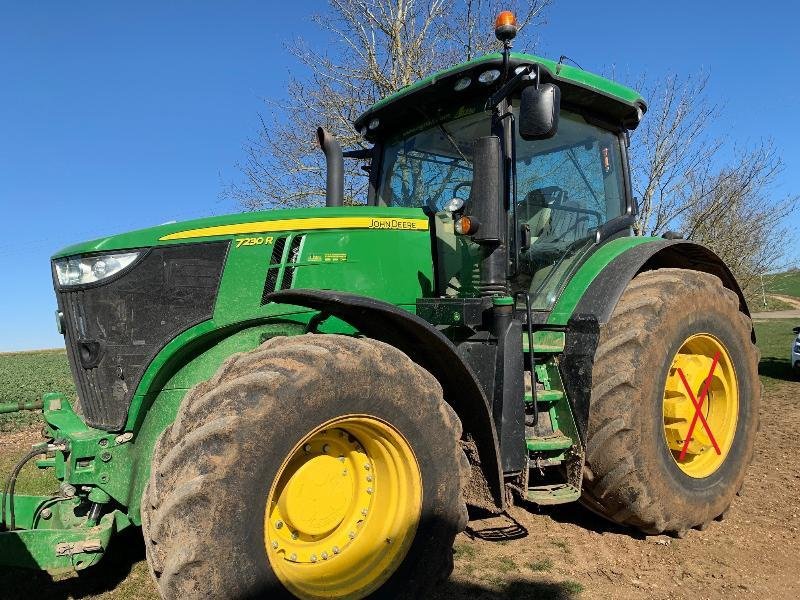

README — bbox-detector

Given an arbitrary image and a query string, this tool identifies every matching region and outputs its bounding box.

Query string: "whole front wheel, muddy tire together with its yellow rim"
[142,335,469,600]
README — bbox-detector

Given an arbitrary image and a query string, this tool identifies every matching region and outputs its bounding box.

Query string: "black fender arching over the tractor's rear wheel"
[560,238,755,445]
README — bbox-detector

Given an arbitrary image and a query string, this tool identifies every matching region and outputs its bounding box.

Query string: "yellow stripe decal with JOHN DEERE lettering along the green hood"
[160,217,428,241]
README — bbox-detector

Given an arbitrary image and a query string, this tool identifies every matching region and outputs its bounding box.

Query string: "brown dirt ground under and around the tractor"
[0,336,800,600]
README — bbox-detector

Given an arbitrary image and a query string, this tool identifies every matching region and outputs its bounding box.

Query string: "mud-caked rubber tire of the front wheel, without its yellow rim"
[142,335,469,600]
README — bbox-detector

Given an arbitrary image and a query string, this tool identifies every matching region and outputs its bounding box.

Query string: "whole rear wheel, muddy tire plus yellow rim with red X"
[581,269,761,535]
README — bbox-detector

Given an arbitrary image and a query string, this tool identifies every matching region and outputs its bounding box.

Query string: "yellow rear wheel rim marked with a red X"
[664,333,739,479]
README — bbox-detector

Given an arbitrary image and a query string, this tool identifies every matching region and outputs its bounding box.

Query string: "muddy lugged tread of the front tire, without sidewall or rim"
[142,334,471,600]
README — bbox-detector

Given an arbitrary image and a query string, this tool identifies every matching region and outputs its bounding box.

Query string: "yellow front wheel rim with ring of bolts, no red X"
[264,415,422,599]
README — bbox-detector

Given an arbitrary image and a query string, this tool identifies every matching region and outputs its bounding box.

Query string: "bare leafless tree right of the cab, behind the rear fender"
[631,71,798,295]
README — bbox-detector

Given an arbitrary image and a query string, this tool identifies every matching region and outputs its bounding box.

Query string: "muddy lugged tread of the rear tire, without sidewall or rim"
[581,269,758,534]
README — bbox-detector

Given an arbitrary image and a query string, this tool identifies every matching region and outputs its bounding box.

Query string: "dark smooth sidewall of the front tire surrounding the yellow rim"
[202,358,461,598]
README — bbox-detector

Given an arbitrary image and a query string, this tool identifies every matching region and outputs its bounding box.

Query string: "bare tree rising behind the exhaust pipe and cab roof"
[227,0,551,209]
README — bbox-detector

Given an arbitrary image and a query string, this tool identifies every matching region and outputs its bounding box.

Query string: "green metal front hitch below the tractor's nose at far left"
[0,394,131,574]
